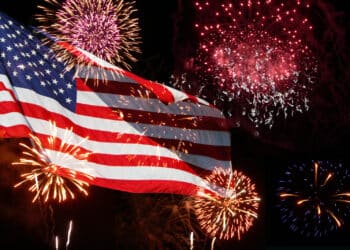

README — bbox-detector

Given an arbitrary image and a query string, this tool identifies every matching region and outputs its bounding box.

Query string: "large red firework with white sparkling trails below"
[172,0,318,128]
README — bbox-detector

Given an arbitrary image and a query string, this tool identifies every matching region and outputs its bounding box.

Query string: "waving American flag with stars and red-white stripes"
[0,13,231,195]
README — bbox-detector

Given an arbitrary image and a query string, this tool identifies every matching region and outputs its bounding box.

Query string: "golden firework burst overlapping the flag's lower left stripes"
[13,123,92,202]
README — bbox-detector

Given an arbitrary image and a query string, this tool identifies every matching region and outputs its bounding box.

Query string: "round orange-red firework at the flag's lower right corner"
[193,168,260,240]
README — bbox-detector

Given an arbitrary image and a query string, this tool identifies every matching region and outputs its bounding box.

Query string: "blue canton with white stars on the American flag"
[0,12,76,111]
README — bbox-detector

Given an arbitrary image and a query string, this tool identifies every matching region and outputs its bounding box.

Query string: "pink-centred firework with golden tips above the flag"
[36,0,140,74]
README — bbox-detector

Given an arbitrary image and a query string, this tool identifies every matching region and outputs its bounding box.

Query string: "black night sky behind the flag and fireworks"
[0,0,350,250]
